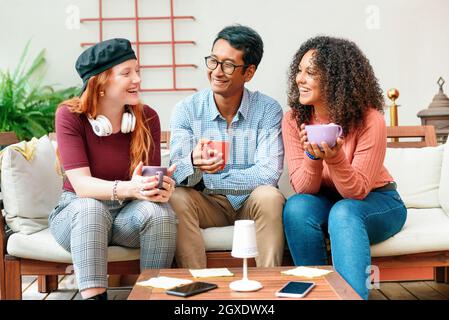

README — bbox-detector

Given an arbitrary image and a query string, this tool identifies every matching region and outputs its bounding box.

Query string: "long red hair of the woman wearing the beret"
[59,69,153,177]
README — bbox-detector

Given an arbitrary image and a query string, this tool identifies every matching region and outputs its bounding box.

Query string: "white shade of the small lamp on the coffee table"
[231,220,259,258]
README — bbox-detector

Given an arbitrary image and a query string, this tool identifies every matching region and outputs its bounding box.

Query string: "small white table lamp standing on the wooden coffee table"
[229,220,263,291]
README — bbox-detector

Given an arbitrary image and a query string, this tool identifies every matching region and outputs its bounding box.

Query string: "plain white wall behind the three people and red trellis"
[0,0,449,129]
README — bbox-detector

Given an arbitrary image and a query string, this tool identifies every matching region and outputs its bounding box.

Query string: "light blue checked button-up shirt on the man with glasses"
[170,89,284,210]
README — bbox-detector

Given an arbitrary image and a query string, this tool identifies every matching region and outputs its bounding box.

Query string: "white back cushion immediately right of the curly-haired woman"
[384,146,443,208]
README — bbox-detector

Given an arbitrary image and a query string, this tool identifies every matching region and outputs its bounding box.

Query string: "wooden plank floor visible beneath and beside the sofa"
[22,275,449,300]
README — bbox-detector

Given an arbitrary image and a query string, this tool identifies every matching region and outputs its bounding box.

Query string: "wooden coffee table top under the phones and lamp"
[128,266,361,300]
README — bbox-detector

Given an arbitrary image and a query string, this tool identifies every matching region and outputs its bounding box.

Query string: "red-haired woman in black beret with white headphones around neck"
[49,39,177,299]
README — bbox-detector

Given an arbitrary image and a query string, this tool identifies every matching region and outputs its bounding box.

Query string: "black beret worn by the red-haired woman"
[75,38,137,96]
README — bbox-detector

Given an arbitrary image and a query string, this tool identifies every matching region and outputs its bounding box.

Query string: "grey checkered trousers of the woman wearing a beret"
[49,191,177,290]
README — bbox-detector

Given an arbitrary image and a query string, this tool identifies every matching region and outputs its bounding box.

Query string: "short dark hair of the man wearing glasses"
[212,25,263,68]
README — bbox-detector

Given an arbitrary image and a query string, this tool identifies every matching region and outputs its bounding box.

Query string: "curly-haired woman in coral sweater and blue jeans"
[282,36,407,299]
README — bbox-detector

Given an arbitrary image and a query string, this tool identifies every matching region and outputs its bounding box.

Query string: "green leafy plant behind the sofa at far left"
[0,42,80,140]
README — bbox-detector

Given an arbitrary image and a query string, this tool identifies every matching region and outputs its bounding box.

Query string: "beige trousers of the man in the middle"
[170,185,285,269]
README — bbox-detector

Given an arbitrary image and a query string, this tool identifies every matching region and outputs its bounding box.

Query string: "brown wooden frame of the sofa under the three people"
[0,126,449,300]
